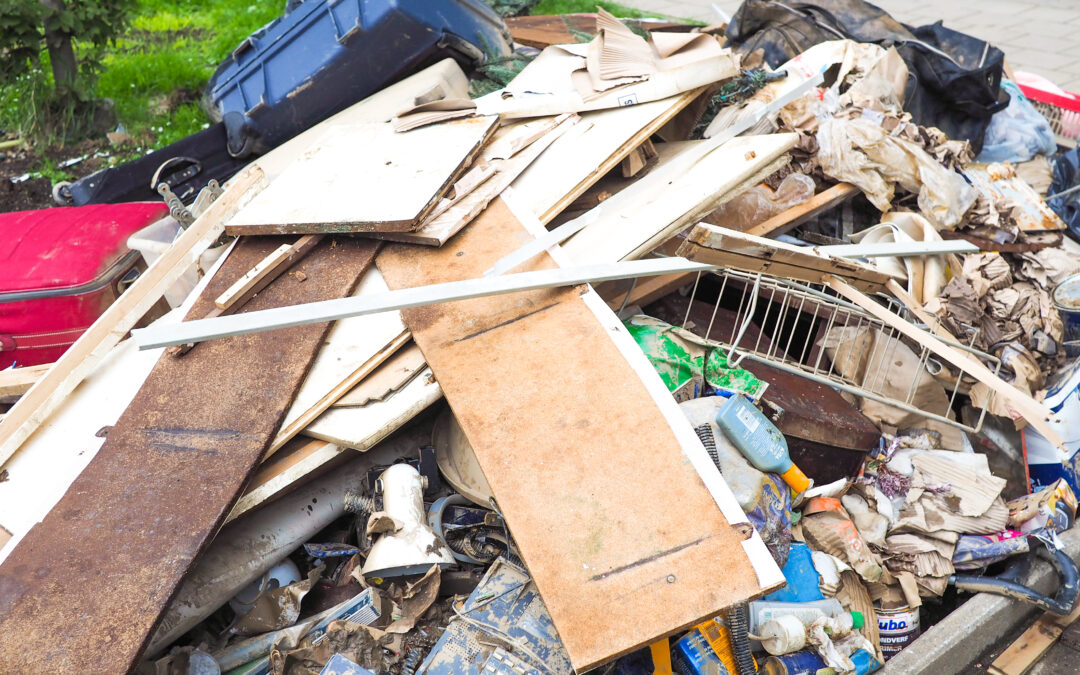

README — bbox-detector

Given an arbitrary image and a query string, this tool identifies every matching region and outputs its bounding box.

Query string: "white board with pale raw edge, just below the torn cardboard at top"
[512,89,704,225]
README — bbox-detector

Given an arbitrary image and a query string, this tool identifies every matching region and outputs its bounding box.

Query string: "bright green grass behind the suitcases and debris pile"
[0,0,691,158]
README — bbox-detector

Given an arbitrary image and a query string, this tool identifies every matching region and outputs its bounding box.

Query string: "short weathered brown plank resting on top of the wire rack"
[677,222,891,293]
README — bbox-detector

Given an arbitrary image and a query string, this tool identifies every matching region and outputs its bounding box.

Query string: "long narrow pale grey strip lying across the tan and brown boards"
[132,258,716,349]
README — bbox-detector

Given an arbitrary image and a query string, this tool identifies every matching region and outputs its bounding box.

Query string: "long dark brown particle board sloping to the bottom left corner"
[0,238,376,673]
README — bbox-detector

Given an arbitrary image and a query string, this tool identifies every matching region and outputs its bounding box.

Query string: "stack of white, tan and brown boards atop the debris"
[0,32,1062,672]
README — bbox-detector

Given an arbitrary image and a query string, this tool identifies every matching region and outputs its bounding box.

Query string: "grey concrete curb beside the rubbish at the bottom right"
[880,529,1080,675]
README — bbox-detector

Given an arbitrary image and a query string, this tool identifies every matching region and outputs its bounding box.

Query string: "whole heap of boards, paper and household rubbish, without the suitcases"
[0,0,1080,675]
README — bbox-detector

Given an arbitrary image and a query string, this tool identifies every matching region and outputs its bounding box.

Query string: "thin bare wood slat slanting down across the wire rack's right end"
[827,271,1065,451]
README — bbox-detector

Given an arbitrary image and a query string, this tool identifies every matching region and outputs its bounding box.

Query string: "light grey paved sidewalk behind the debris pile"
[620,0,1080,92]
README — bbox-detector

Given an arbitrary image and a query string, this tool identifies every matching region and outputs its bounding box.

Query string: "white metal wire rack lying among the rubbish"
[665,269,1001,432]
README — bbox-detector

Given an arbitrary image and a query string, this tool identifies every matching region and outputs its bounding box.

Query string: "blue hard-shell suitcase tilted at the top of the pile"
[204,0,511,157]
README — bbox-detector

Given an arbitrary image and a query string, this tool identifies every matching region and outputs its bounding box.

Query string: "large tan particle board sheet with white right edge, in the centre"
[377,198,783,672]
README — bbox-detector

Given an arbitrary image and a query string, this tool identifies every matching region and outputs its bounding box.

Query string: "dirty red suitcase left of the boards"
[0,203,168,368]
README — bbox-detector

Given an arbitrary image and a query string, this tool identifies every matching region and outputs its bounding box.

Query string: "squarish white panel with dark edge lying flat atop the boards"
[226,116,499,234]
